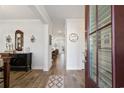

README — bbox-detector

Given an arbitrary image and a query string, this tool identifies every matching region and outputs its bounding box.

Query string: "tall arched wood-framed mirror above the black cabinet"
[15,30,24,51]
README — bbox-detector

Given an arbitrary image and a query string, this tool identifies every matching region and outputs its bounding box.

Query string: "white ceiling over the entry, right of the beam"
[45,5,84,22]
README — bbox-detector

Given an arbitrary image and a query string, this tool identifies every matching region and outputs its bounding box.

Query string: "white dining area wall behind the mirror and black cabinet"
[0,19,48,69]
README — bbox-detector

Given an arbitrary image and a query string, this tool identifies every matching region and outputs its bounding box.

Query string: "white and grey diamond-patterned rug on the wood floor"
[46,75,64,88]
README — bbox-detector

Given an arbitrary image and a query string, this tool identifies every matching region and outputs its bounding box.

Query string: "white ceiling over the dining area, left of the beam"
[0,5,39,19]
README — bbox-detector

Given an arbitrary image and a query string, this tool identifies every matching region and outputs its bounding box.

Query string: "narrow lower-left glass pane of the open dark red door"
[89,33,97,82]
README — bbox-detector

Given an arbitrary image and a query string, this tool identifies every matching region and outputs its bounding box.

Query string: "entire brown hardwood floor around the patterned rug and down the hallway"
[0,53,85,88]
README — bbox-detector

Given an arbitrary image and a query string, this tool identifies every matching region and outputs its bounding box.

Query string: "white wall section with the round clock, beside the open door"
[66,19,85,70]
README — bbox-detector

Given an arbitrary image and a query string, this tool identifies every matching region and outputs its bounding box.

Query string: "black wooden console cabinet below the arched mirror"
[10,53,32,71]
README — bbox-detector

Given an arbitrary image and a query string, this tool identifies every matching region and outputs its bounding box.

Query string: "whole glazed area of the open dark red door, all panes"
[89,5,112,87]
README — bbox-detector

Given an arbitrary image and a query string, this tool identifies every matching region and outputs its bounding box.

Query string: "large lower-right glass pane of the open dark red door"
[98,25,112,88]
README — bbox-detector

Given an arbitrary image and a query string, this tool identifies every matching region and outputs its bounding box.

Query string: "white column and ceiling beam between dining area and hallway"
[32,6,52,71]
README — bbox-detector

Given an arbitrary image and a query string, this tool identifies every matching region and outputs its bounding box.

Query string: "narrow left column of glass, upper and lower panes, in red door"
[89,5,97,82]
